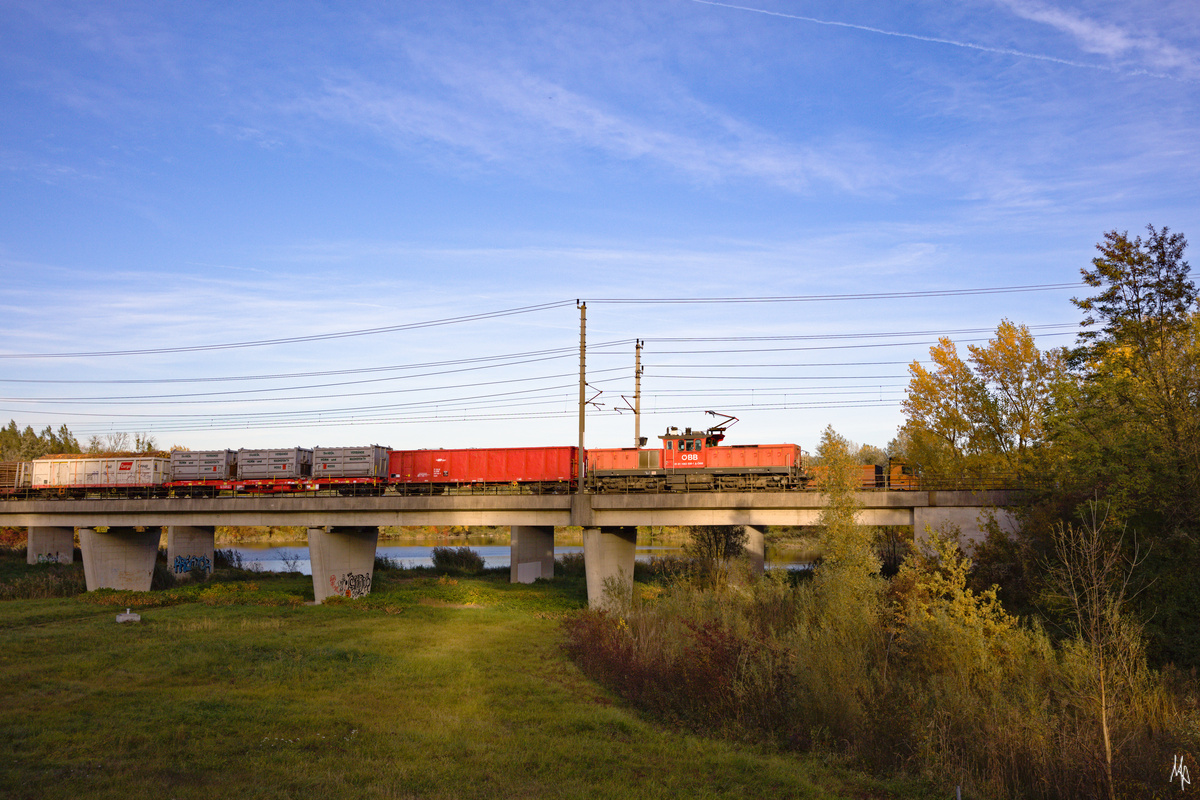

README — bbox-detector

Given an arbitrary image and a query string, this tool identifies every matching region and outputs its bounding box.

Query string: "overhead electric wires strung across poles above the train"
[0,283,1079,438]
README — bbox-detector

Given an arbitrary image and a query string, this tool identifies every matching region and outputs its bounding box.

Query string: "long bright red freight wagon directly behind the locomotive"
[388,447,578,492]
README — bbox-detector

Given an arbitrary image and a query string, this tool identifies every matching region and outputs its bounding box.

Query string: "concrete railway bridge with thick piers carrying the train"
[0,491,1021,606]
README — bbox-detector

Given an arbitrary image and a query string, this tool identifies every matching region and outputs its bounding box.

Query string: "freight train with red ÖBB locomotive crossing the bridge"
[0,411,917,498]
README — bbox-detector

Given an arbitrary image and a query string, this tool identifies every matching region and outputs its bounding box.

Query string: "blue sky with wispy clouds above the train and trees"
[0,0,1200,450]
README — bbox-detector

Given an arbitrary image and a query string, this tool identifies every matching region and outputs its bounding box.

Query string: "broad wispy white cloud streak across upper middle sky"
[288,50,894,192]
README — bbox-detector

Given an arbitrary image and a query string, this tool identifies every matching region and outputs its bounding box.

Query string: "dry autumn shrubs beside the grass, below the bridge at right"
[566,522,1200,799]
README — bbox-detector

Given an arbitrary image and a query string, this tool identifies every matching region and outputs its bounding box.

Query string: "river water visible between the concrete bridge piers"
[217,539,808,575]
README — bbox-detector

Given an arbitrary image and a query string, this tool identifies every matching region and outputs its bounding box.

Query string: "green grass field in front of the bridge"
[0,556,926,800]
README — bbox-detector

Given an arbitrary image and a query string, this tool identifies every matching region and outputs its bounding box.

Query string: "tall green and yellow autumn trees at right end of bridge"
[890,225,1200,668]
